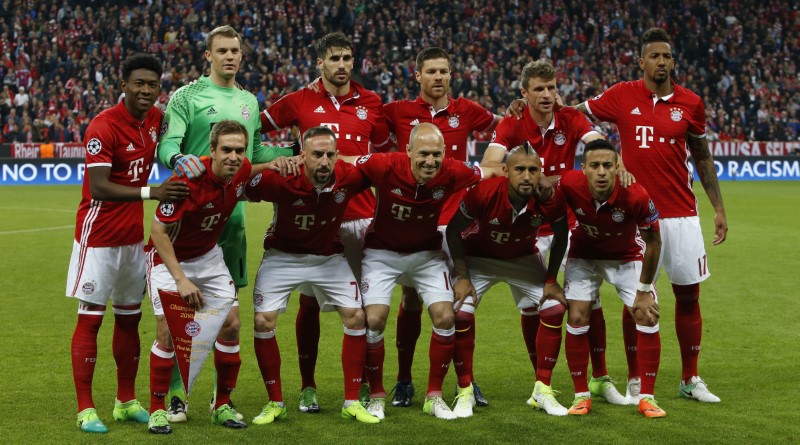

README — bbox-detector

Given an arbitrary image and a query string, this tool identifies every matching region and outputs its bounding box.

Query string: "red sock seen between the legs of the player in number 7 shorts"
[294,294,319,389]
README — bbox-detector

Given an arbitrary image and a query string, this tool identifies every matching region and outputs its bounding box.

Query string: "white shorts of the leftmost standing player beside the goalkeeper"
[66,241,147,306]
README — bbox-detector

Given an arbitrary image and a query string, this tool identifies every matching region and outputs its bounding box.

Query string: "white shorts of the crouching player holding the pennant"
[147,245,238,316]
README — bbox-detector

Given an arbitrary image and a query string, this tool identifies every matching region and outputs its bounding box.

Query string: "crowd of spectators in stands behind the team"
[0,0,800,146]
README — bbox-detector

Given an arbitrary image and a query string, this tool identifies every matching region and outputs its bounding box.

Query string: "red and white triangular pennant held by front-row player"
[158,289,234,395]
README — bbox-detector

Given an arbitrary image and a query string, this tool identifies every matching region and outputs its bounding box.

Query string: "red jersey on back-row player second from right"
[492,106,596,236]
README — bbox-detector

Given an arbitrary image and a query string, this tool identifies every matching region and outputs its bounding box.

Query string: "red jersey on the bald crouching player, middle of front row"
[356,152,481,253]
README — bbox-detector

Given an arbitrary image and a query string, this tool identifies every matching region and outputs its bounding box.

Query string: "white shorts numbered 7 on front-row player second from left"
[253,249,361,313]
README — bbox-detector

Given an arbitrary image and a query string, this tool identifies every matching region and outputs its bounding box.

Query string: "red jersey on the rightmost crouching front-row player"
[559,170,659,261]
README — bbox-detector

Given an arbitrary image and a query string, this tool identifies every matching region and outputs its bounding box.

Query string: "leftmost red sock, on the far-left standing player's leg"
[71,306,105,412]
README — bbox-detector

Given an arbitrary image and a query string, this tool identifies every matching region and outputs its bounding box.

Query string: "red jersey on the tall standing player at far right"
[586,80,706,218]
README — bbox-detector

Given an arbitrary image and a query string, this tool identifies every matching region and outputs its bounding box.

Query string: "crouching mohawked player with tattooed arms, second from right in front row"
[447,143,568,417]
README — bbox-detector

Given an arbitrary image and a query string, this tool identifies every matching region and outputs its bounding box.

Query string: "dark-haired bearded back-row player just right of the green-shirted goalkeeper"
[261,32,389,413]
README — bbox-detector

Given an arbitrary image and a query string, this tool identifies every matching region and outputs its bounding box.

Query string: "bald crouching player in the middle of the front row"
[356,123,494,419]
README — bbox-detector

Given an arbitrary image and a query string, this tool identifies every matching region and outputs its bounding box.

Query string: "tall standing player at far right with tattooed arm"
[577,28,728,402]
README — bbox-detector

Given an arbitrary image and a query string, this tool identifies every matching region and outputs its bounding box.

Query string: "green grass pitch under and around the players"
[0,182,800,444]
